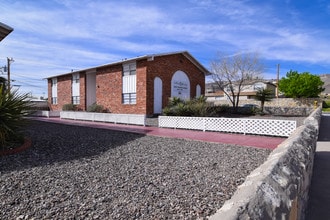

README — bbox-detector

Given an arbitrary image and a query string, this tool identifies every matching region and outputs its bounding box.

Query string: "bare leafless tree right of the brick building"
[211,53,264,109]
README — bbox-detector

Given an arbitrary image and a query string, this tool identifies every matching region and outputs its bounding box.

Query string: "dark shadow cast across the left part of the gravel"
[0,121,144,172]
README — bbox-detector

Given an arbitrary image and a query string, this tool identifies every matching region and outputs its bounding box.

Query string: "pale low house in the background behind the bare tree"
[205,80,276,102]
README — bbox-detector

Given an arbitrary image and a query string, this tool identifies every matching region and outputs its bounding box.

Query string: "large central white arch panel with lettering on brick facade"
[171,70,190,99]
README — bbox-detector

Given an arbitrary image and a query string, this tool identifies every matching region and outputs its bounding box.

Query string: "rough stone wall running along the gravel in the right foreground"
[210,108,322,220]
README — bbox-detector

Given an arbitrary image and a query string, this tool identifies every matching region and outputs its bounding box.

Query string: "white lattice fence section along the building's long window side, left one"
[60,111,146,126]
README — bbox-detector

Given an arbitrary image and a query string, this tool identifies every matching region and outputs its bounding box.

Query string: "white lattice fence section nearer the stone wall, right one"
[158,116,297,137]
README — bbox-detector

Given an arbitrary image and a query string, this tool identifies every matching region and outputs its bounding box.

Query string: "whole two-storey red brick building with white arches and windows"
[47,51,209,115]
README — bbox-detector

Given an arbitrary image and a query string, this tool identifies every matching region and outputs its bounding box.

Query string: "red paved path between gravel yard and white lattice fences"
[33,117,285,149]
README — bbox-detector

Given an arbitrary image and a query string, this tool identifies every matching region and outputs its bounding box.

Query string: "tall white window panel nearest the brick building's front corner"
[122,62,136,104]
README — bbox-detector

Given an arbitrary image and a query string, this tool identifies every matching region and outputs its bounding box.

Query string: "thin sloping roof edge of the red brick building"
[46,51,211,79]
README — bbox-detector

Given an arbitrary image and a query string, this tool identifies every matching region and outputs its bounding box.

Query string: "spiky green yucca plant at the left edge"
[0,85,31,149]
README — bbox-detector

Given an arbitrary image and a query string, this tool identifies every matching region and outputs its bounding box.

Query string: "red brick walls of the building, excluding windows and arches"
[48,54,205,115]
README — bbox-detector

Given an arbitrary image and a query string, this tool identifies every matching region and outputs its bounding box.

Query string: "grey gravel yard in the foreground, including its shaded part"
[0,121,270,219]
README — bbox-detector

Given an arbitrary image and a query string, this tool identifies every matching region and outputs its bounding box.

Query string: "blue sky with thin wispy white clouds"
[0,0,330,96]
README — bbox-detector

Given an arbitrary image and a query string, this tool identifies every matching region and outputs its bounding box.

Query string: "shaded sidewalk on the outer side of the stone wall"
[306,114,330,220]
